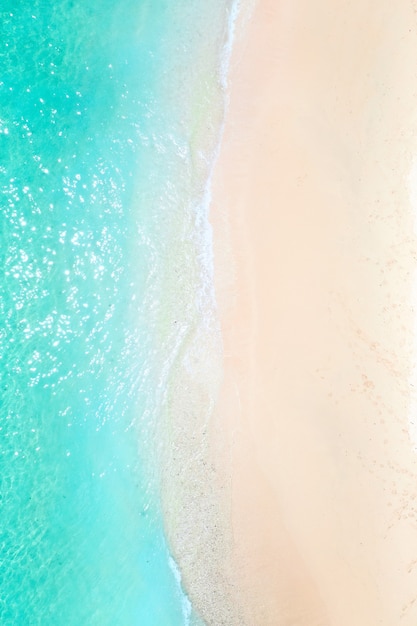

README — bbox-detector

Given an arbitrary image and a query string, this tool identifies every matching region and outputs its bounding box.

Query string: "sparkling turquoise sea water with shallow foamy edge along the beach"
[0,0,236,626]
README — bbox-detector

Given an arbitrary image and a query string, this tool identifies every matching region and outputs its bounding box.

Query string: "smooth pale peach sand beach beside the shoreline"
[208,0,417,626]
